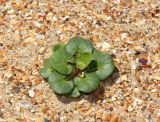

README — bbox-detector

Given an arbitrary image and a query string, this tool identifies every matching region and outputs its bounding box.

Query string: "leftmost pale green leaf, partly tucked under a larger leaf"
[40,58,54,79]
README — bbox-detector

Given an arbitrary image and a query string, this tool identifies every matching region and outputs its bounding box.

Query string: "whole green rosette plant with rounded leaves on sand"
[40,36,115,97]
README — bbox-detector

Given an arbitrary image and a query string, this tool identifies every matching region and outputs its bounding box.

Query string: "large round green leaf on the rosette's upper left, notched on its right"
[52,47,74,75]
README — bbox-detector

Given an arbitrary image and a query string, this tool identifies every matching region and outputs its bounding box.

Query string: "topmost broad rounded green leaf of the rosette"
[66,36,93,55]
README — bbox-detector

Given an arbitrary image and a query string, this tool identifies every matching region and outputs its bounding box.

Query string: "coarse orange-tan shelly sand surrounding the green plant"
[0,0,160,122]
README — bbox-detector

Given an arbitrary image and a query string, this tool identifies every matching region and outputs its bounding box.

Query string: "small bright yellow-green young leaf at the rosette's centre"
[76,53,92,70]
